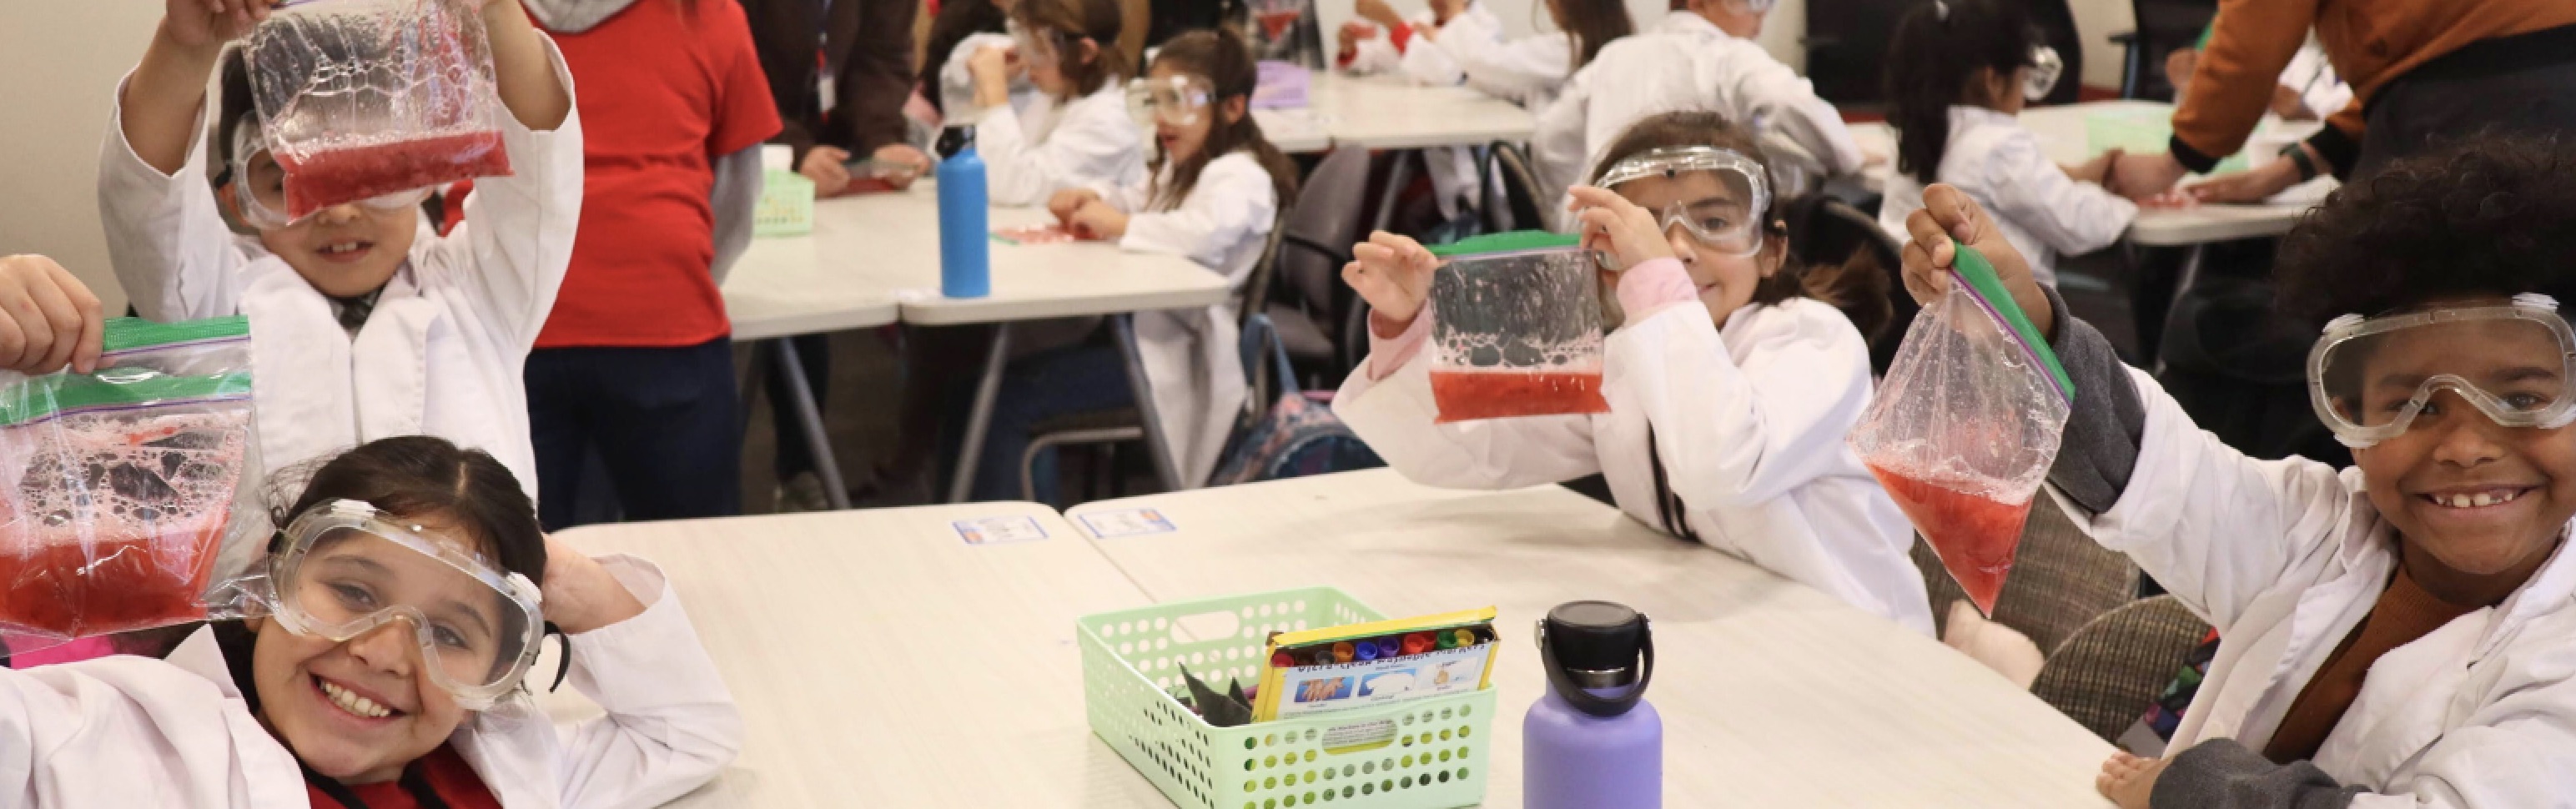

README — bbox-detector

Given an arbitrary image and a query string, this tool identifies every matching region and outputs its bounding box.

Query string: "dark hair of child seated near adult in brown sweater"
[1885,0,2045,185]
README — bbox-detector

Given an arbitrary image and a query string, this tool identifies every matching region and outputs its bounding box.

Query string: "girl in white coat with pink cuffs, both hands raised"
[1331,113,1932,634]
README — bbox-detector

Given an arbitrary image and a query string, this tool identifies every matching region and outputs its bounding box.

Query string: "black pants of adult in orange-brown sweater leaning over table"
[2349,26,2576,178]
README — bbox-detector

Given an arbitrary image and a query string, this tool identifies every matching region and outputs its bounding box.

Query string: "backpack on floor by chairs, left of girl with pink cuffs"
[1208,314,1386,487]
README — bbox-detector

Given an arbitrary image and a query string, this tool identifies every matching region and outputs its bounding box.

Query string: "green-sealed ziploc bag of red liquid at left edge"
[0,317,268,652]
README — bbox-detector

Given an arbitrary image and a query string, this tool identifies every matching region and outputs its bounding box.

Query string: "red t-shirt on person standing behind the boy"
[536,0,778,348]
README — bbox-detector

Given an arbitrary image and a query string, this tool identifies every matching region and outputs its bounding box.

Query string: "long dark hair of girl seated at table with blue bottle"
[1151,26,1296,209]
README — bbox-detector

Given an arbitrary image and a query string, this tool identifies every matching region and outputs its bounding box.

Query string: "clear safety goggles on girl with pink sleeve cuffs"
[1592,147,1769,255]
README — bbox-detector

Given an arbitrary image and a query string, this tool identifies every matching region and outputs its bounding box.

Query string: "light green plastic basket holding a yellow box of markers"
[1074,587,1497,809]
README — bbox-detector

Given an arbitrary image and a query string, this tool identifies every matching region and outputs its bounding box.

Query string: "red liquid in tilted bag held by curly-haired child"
[1870,464,2032,616]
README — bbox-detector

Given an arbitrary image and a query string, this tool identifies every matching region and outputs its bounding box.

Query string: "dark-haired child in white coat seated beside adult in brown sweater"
[1878,0,2138,286]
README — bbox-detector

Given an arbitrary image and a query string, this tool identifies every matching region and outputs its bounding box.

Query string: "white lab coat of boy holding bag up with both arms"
[98,38,582,497]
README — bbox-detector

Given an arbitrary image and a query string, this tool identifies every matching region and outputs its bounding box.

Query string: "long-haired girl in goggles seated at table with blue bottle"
[974,27,1296,502]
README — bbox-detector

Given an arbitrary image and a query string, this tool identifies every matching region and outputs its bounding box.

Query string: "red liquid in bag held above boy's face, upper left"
[275,132,510,216]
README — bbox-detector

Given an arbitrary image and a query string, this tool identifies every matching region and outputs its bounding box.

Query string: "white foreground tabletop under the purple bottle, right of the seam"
[1066,469,2112,806]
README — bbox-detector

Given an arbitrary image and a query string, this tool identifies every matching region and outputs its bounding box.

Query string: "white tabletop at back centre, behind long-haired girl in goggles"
[1252,69,1538,152]
